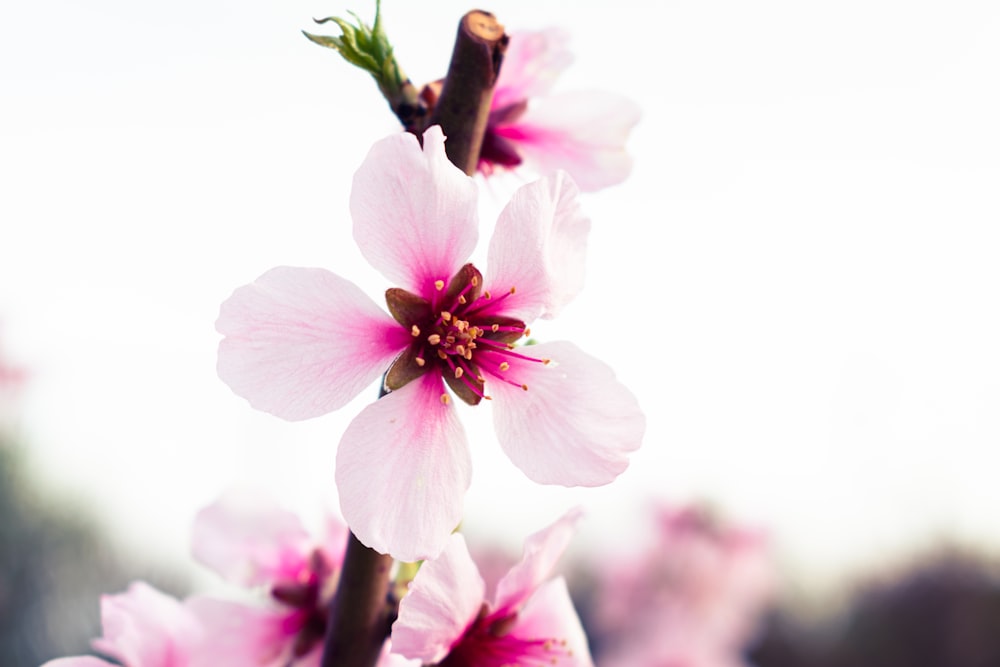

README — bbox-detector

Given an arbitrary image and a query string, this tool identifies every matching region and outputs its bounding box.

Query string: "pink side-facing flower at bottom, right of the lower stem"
[392,512,593,667]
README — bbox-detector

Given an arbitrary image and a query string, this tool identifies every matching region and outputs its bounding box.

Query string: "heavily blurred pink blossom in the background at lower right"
[594,507,775,667]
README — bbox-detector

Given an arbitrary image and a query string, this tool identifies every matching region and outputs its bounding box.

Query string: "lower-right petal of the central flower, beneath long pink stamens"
[488,341,646,486]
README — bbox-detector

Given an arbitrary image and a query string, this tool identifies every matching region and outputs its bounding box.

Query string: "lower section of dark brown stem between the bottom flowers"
[322,533,396,667]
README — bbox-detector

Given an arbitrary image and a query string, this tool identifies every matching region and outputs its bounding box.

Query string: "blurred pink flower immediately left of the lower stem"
[188,491,347,667]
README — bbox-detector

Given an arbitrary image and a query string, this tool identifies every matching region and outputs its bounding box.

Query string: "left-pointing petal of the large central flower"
[215,267,409,421]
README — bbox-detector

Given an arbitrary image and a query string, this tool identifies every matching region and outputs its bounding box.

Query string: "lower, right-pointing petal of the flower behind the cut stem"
[493,92,641,192]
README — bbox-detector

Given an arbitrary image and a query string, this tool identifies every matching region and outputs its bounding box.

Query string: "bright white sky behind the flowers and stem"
[0,0,1000,604]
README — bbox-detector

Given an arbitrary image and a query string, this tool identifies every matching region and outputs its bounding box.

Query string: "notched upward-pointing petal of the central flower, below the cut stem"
[351,125,479,294]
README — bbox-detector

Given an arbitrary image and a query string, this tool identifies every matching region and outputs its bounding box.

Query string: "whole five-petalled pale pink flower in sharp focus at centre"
[216,127,645,561]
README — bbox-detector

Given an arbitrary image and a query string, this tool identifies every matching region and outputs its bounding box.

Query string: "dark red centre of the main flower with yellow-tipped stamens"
[385,264,548,405]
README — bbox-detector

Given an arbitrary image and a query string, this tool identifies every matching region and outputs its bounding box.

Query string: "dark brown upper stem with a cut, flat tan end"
[428,10,508,176]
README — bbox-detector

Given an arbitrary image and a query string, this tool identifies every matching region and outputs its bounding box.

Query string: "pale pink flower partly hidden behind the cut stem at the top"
[479,30,640,191]
